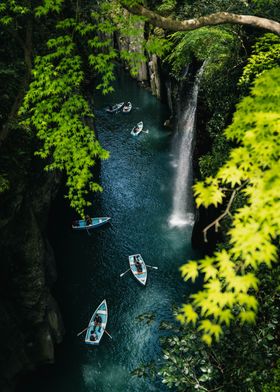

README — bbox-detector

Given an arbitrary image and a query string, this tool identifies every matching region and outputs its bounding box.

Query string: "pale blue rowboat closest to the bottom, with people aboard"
[85,299,108,346]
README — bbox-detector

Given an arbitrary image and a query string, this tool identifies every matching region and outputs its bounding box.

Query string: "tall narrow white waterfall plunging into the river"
[169,63,205,227]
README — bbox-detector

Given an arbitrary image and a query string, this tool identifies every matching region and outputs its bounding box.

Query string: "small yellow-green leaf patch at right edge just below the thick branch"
[239,34,280,88]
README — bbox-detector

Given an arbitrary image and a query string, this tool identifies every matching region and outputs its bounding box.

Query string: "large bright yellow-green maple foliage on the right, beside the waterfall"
[178,68,280,344]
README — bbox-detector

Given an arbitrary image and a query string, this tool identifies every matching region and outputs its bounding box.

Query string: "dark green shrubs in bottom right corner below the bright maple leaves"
[141,264,280,392]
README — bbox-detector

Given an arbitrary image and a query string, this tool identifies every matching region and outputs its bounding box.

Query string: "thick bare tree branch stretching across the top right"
[121,1,280,35]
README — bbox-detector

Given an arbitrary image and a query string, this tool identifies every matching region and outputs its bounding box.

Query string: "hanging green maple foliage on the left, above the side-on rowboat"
[21,35,108,215]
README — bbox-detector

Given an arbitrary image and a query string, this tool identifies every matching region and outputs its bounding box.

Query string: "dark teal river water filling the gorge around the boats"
[20,74,198,392]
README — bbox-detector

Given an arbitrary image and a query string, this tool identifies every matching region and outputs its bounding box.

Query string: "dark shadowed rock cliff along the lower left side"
[0,133,63,391]
